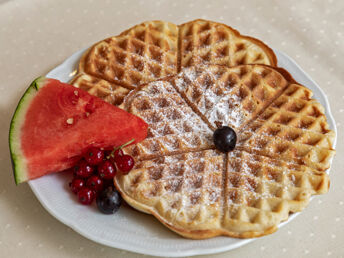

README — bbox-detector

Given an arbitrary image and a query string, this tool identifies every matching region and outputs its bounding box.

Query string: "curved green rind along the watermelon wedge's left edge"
[8,77,46,184]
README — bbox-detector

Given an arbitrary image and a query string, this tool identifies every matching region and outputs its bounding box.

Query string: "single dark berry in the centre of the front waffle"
[213,126,237,152]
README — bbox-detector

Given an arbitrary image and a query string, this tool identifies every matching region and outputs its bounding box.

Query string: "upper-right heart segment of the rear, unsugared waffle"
[179,20,277,67]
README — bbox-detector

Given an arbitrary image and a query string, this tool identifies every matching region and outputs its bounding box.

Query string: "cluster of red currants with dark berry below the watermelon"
[69,146,134,214]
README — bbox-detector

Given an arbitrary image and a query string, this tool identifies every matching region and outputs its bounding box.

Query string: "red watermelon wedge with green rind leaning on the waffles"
[9,77,148,184]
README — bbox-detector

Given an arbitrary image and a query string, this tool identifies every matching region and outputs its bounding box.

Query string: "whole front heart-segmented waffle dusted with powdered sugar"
[115,65,334,239]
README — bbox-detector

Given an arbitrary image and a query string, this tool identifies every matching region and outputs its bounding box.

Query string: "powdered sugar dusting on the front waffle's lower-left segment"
[137,150,224,210]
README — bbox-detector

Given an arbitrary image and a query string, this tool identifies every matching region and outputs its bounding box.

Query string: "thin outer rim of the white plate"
[28,48,337,257]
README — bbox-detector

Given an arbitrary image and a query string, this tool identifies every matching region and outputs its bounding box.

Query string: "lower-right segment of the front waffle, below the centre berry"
[221,151,329,238]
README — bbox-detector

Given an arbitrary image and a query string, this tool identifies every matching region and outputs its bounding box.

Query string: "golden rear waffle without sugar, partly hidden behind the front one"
[71,20,277,105]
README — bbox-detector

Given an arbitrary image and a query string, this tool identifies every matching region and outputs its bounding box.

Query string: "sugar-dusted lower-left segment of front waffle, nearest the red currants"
[123,150,225,229]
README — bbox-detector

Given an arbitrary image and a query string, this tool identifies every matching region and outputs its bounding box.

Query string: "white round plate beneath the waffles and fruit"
[29,50,337,257]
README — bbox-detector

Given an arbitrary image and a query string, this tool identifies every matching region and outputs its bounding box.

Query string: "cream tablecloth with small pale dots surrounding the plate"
[0,0,344,258]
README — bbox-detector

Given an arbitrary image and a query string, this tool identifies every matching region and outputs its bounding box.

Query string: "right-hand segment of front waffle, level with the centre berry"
[244,84,335,170]
